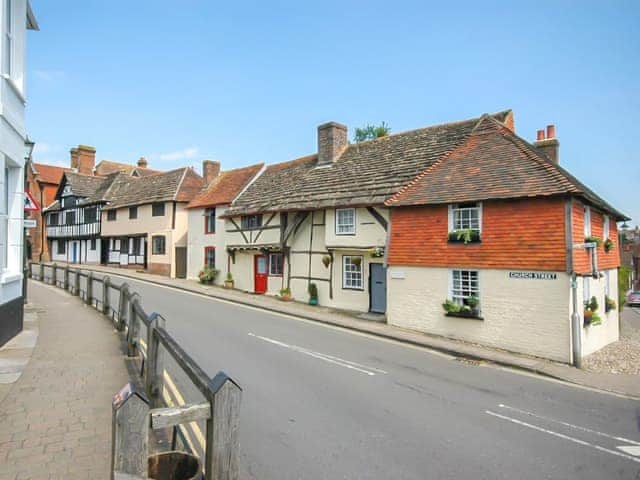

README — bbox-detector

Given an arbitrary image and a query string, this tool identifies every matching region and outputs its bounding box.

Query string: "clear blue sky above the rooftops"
[27,0,640,221]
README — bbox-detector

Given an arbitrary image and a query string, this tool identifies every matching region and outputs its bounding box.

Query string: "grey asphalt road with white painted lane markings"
[91,276,640,480]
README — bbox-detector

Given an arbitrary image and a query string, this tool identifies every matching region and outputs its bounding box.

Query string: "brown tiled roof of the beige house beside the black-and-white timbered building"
[105,167,203,210]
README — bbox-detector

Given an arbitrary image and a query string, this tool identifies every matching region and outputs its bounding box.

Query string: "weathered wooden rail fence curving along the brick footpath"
[28,263,242,480]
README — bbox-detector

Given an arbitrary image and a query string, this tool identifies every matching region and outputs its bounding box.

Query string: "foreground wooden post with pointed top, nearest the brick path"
[111,383,149,479]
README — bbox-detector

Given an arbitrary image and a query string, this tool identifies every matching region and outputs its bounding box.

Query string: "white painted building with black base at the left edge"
[0,0,38,345]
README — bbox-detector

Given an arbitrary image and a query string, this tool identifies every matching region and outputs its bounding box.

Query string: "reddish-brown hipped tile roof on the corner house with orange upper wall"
[385,116,626,219]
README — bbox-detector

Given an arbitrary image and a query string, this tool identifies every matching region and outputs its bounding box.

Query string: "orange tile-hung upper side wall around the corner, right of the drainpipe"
[571,201,620,273]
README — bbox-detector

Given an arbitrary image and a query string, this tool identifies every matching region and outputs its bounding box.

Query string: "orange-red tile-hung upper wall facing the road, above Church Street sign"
[389,198,567,271]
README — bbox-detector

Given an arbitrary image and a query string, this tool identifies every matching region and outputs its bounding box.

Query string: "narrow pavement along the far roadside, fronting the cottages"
[55,265,640,399]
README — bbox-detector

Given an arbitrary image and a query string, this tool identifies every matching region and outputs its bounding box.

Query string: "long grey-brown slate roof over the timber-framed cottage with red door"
[227,110,511,215]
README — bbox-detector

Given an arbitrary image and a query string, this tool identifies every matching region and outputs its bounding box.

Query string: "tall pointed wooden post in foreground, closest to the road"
[205,372,242,480]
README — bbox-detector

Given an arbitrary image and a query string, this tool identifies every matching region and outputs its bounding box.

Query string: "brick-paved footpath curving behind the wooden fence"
[0,282,128,480]
